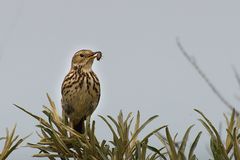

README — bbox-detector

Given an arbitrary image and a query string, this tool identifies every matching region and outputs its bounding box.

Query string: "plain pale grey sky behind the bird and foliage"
[0,0,240,160]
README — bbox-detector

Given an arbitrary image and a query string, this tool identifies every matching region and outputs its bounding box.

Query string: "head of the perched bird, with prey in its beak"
[72,50,102,70]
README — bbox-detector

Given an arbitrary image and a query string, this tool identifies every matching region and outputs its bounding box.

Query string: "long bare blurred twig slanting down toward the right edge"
[176,38,239,114]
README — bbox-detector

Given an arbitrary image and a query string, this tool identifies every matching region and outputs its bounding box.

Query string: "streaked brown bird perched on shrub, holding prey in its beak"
[61,50,102,133]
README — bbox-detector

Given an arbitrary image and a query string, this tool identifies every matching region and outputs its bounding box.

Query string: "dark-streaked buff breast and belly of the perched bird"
[62,71,100,118]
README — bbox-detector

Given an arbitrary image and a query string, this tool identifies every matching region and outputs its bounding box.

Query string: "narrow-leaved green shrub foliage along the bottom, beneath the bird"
[0,96,240,160]
